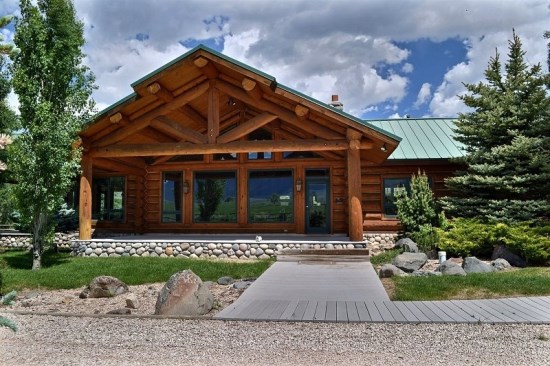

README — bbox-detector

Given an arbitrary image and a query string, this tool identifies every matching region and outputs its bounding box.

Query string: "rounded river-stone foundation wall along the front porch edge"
[72,240,366,260]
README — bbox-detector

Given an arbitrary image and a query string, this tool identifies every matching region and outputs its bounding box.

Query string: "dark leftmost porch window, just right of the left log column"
[92,177,125,222]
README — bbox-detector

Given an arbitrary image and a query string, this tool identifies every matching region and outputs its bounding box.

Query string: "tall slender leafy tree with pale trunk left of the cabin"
[8,0,93,269]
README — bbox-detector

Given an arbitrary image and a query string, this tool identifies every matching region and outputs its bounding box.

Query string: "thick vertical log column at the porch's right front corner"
[347,130,363,241]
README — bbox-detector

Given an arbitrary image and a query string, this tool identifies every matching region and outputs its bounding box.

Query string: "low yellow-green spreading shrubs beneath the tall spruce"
[436,219,550,264]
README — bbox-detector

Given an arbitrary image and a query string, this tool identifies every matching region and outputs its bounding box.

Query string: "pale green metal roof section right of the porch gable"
[368,118,464,160]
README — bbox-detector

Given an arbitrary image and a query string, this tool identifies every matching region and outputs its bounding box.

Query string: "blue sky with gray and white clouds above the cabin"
[0,0,550,118]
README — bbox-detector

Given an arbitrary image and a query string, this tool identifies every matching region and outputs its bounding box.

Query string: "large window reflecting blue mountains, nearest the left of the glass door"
[248,170,294,223]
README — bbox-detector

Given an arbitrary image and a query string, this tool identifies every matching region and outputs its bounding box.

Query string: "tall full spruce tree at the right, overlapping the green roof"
[445,32,550,222]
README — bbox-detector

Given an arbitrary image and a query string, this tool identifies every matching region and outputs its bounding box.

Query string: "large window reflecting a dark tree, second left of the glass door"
[193,172,237,222]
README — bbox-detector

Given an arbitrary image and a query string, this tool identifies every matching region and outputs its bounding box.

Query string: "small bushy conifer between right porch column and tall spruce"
[395,171,441,252]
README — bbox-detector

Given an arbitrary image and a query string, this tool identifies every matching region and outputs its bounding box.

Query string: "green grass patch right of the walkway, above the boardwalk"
[391,267,550,301]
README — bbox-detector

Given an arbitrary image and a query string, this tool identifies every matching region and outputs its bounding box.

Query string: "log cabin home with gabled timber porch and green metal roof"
[79,45,461,241]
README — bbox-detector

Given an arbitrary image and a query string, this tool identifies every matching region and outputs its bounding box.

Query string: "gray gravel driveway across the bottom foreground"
[0,313,550,366]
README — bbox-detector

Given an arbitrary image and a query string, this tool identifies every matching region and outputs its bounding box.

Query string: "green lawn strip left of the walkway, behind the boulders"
[0,251,273,293]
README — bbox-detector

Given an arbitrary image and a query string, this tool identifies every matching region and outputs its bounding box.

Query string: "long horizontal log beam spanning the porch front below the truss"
[90,140,350,158]
